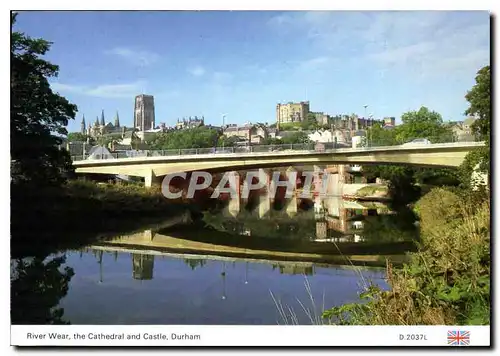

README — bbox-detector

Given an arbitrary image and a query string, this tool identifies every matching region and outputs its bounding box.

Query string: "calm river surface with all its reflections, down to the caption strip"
[11,199,415,324]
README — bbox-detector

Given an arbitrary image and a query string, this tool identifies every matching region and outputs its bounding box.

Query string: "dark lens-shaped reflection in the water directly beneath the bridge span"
[203,195,418,242]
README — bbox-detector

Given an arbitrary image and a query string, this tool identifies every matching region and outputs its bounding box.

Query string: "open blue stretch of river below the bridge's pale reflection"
[50,247,385,325]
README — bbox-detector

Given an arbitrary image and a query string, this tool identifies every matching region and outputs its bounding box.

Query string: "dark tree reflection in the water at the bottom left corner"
[10,256,74,325]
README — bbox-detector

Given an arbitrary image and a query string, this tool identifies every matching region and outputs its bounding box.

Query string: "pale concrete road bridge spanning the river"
[73,142,485,186]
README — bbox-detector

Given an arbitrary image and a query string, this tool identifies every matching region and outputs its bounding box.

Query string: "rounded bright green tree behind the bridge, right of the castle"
[395,106,453,144]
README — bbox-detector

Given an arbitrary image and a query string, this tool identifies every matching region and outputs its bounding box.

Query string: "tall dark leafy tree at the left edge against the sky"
[10,14,77,187]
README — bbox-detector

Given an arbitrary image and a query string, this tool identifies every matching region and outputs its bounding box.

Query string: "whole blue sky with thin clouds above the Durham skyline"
[15,11,490,131]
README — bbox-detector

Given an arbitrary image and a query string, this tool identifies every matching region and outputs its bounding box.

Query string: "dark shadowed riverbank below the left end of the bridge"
[11,181,197,256]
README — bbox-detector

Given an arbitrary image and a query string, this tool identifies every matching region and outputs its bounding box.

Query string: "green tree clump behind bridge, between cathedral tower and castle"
[150,126,220,150]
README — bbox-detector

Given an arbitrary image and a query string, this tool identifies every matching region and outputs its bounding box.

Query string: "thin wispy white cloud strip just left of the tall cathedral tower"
[50,81,146,98]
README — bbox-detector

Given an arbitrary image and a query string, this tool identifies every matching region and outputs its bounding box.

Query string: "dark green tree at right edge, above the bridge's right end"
[465,66,491,140]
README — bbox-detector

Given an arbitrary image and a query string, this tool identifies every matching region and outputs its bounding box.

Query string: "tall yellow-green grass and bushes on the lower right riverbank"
[323,188,490,325]
